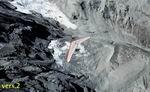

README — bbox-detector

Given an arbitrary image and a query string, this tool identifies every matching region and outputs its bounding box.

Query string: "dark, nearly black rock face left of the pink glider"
[0,1,95,92]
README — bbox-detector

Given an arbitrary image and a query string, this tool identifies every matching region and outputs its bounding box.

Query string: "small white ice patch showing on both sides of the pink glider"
[48,40,89,66]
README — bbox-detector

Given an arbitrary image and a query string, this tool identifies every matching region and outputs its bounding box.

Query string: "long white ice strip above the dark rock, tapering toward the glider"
[11,0,77,29]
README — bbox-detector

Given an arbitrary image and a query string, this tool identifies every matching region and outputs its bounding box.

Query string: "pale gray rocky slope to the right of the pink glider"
[55,0,150,92]
